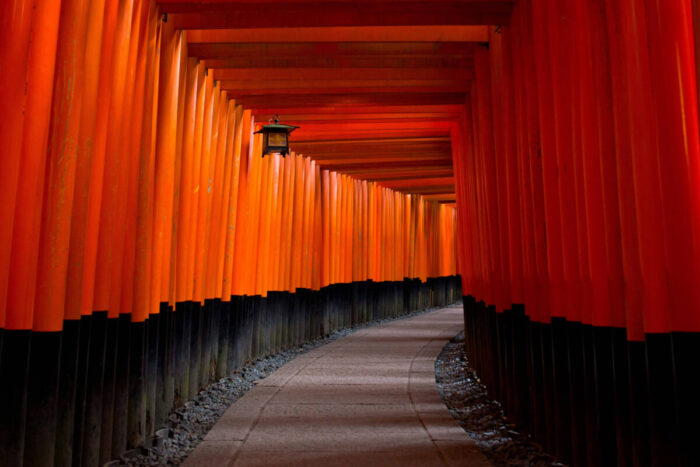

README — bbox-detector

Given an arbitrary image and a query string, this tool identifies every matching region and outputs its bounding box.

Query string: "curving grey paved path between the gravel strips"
[185,307,490,467]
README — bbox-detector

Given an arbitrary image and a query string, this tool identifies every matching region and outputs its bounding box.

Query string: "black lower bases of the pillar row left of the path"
[5,277,462,466]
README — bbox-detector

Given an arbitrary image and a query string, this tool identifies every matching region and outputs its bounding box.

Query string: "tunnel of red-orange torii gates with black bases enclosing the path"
[0,0,700,466]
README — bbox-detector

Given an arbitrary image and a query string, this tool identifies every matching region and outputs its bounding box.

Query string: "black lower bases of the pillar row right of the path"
[463,296,700,466]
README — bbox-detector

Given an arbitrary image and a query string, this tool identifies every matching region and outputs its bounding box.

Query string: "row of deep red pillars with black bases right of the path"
[452,0,700,465]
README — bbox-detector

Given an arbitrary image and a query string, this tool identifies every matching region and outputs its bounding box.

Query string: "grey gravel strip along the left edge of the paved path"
[105,307,444,467]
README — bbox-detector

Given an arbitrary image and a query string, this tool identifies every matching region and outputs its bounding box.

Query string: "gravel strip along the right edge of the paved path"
[435,332,564,467]
